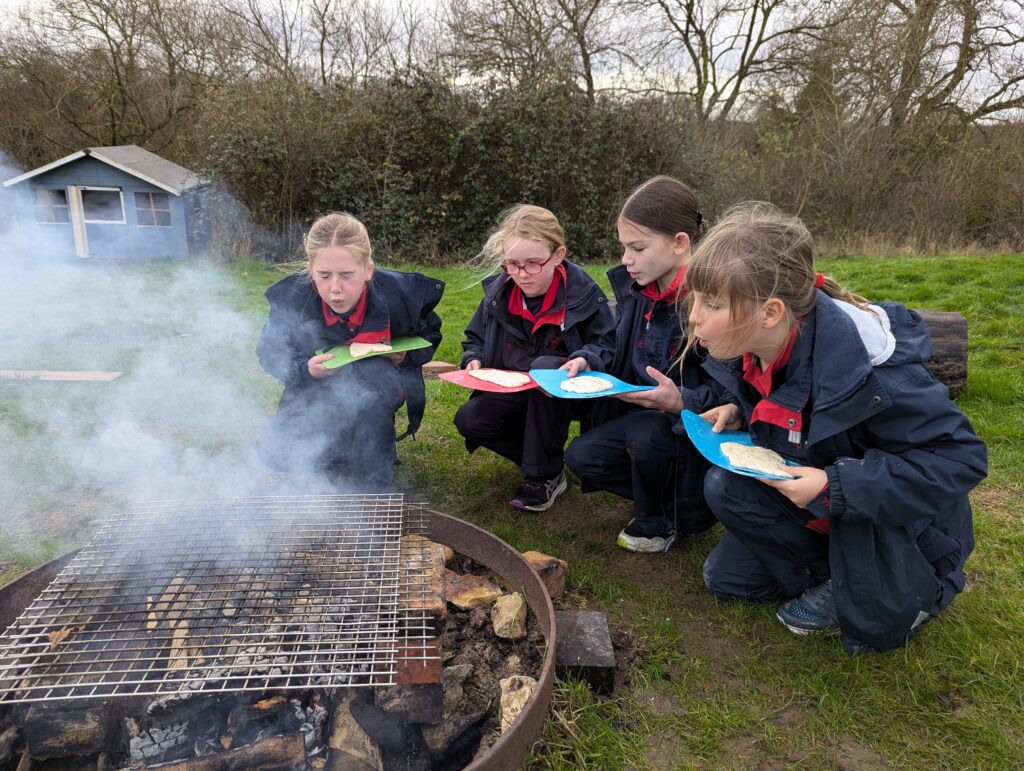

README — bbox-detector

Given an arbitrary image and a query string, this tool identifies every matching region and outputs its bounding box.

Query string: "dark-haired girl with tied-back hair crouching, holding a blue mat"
[562,176,715,553]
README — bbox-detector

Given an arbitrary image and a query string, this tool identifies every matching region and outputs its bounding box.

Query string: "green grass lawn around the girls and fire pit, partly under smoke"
[0,255,1024,769]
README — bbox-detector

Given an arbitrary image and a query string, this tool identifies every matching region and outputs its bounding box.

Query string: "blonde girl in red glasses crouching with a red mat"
[455,205,612,512]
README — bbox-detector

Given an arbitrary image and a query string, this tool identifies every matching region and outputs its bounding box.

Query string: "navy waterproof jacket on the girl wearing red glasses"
[460,261,613,368]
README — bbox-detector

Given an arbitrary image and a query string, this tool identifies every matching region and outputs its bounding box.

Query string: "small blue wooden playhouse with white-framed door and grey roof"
[3,144,210,260]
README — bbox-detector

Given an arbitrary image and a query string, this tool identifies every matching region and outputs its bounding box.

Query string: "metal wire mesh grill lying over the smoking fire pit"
[0,494,438,703]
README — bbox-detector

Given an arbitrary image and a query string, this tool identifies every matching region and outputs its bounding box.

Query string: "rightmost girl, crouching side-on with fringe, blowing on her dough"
[687,204,986,653]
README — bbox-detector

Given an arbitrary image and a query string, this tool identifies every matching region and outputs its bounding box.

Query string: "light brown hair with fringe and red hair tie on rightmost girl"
[686,201,868,350]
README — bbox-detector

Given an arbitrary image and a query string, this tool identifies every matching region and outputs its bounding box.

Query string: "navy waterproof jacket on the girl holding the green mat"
[256,267,444,438]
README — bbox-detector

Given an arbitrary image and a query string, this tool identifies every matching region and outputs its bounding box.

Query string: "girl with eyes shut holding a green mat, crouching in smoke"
[256,212,444,490]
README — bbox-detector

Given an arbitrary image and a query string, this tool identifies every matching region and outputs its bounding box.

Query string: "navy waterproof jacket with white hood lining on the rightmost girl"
[687,291,987,653]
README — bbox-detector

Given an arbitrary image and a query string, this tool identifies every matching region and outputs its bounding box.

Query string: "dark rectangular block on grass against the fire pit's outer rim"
[555,610,615,693]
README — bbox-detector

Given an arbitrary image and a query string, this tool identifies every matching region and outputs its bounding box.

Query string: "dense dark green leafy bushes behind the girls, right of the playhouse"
[198,75,673,262]
